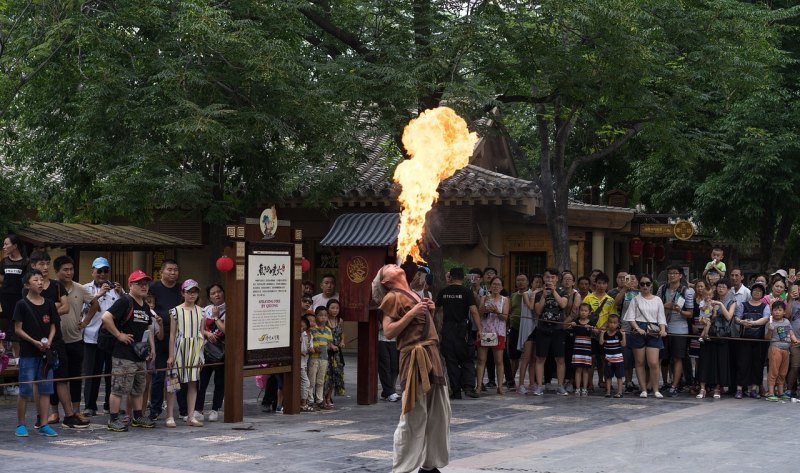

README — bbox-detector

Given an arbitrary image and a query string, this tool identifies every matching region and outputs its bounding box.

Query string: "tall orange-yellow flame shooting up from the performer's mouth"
[394,107,478,261]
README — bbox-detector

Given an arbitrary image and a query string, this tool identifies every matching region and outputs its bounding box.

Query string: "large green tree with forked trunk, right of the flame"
[476,0,780,268]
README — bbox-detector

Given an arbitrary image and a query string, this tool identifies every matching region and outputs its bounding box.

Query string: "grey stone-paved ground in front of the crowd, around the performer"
[0,358,800,473]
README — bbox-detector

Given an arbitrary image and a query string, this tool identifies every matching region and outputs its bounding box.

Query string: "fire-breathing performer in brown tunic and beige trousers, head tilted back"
[372,264,450,473]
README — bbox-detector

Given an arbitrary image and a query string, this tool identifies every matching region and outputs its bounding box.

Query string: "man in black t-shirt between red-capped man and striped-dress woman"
[149,259,182,420]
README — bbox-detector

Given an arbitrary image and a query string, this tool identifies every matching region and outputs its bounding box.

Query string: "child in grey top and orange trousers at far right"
[764,301,797,401]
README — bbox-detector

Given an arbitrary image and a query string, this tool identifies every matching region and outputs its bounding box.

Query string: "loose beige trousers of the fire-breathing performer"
[392,385,450,473]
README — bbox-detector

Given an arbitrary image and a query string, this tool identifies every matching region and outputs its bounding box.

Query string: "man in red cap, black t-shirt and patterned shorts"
[103,270,156,432]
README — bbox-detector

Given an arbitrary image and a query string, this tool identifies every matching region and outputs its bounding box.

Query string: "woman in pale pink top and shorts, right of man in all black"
[475,277,509,394]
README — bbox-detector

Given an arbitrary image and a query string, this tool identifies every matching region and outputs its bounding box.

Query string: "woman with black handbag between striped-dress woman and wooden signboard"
[194,283,225,422]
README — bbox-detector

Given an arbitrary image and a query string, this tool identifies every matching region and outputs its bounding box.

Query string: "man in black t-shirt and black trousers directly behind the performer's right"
[436,268,481,399]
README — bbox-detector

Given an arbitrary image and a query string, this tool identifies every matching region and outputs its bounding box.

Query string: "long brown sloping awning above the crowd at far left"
[16,223,203,251]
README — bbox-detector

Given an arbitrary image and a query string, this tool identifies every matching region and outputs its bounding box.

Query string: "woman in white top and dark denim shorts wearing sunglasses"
[625,275,667,399]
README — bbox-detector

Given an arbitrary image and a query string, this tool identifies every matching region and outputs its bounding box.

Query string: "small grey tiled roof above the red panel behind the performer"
[320,213,400,246]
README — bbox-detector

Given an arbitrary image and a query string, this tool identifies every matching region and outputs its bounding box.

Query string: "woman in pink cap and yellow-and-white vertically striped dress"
[167,279,208,427]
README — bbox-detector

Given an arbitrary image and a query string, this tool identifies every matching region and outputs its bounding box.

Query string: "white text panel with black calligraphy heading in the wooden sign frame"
[244,243,294,366]
